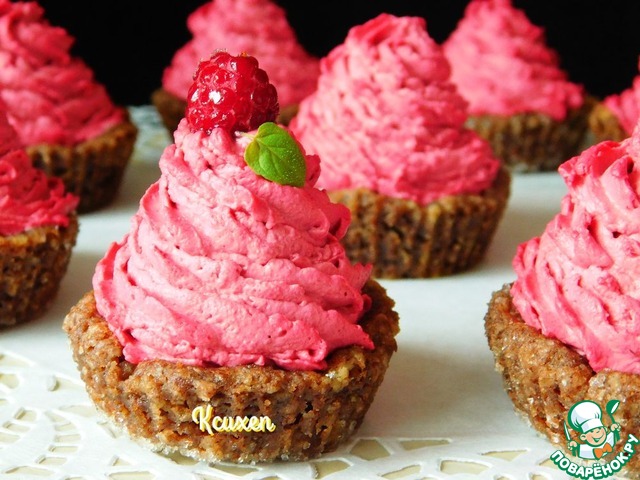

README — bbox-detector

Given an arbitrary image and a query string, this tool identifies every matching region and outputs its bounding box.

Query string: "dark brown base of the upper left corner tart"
[27,116,138,213]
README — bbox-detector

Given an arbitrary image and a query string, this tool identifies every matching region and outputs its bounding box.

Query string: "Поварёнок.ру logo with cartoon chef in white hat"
[550,400,638,480]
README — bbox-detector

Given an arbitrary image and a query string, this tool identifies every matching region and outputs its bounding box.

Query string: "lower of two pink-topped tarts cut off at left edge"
[0,102,78,327]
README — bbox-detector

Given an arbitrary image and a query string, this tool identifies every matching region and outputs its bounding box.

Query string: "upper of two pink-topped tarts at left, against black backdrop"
[0,0,137,213]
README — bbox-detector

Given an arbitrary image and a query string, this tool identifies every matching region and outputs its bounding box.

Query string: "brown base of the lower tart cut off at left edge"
[0,213,78,327]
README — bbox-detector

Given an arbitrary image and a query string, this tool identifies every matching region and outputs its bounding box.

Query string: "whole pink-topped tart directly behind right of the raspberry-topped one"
[290,13,510,278]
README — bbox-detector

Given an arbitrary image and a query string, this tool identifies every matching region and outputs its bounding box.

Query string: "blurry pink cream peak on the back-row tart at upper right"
[443,0,583,120]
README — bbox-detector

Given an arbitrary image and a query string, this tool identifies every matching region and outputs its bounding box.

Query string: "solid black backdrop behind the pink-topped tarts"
[39,0,640,105]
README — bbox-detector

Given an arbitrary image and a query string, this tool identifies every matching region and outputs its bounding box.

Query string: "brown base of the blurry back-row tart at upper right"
[466,98,594,172]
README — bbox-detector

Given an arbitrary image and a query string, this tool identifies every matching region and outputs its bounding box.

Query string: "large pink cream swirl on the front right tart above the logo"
[511,121,640,374]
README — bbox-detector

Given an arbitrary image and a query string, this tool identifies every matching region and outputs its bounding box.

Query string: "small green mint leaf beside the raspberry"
[244,122,307,187]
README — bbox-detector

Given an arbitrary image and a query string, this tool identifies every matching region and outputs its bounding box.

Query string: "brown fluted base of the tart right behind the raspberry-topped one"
[328,167,511,278]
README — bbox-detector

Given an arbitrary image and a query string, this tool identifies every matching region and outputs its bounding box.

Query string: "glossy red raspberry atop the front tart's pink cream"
[186,51,279,133]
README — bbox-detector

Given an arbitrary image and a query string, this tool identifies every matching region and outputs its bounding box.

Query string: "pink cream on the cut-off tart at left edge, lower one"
[0,106,79,235]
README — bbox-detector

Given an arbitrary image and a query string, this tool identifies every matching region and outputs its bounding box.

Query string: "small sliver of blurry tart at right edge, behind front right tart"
[589,59,640,143]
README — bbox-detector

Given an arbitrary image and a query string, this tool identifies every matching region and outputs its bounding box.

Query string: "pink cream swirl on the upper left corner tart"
[0,0,124,145]
